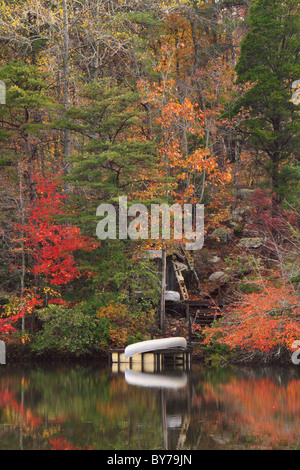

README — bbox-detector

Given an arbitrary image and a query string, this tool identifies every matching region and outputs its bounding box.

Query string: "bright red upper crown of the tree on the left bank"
[23,175,96,285]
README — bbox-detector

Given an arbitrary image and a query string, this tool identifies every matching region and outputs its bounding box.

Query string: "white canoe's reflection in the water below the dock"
[125,369,187,389]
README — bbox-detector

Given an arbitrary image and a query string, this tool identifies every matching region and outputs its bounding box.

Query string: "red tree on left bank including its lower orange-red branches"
[0,173,99,333]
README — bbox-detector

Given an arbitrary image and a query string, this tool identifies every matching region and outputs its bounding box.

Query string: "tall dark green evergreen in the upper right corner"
[236,0,300,193]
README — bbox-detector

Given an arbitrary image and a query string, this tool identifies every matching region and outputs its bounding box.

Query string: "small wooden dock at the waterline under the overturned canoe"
[109,348,192,372]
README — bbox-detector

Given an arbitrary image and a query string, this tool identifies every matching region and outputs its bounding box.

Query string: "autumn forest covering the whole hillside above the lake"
[0,0,300,362]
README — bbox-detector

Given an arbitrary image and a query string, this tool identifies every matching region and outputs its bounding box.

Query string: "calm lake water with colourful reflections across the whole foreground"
[0,363,300,450]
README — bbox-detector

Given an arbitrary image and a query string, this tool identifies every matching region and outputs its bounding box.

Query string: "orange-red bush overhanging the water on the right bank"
[205,281,300,355]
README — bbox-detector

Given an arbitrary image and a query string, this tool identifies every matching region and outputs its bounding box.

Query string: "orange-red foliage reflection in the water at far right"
[194,370,300,449]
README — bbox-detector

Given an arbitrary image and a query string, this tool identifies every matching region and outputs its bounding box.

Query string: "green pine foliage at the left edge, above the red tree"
[0,61,54,171]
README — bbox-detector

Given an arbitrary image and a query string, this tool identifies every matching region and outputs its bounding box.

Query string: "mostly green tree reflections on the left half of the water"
[0,366,161,449]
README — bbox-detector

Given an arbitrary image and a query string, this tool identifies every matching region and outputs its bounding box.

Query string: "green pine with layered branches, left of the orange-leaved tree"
[65,79,154,196]
